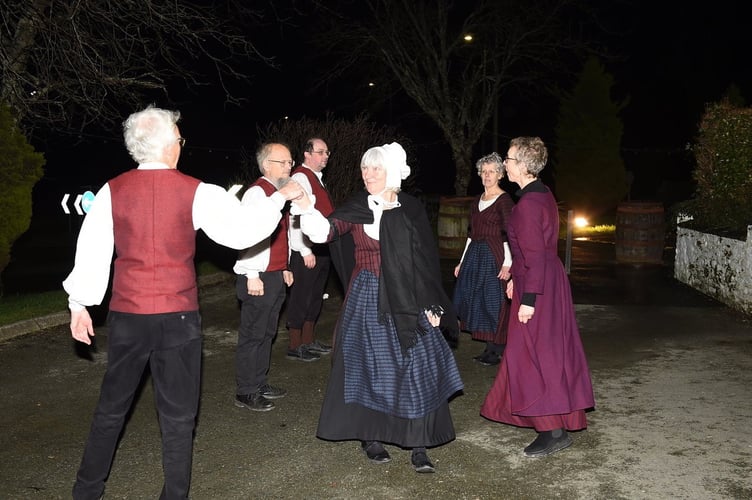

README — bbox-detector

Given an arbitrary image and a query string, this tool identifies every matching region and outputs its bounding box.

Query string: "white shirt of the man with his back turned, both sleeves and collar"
[63,163,285,311]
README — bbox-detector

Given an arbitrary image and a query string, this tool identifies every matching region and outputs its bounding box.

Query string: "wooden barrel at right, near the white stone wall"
[616,201,666,264]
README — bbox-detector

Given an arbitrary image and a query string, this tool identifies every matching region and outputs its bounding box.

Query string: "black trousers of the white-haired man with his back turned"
[73,311,201,499]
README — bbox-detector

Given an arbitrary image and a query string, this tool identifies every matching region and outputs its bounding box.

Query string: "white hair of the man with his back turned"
[123,106,180,164]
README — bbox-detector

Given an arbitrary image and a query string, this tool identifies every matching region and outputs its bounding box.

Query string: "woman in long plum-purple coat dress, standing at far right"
[481,137,595,457]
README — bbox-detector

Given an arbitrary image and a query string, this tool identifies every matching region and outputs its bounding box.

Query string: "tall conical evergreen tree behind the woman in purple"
[555,57,628,217]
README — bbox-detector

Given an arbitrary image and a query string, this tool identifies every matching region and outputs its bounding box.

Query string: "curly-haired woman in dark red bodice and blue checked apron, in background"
[454,153,514,366]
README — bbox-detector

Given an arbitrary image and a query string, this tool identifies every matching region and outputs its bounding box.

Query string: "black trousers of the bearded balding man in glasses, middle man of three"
[235,271,287,394]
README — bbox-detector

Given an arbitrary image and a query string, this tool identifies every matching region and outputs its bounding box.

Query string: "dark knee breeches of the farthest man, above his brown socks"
[287,252,331,329]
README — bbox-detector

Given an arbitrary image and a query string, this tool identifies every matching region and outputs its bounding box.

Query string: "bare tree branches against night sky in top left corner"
[0,0,272,135]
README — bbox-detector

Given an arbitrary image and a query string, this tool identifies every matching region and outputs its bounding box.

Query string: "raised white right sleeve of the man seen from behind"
[193,182,285,250]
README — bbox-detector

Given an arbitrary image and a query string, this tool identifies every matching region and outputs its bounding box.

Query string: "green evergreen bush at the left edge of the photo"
[0,104,45,296]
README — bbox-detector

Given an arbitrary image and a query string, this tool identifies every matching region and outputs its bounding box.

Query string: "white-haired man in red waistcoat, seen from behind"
[63,107,304,499]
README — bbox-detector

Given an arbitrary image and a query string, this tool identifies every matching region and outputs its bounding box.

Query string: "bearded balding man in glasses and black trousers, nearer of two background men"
[233,143,295,411]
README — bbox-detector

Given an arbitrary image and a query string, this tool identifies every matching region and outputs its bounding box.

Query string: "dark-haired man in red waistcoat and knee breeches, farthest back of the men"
[287,137,334,362]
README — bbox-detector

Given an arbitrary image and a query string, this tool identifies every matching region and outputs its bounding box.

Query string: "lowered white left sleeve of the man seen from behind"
[63,184,115,311]
